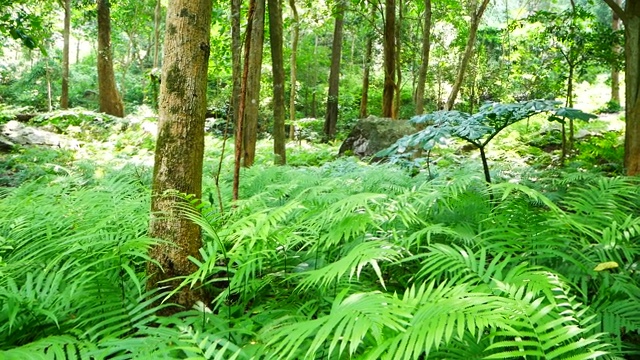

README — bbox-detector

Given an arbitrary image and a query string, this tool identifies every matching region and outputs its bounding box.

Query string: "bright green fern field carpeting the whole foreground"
[0,160,640,360]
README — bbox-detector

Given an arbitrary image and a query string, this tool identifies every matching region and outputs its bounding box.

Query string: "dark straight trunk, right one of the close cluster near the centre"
[269,0,287,165]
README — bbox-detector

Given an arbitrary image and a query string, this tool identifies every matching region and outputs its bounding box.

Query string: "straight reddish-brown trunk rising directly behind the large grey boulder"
[382,0,396,117]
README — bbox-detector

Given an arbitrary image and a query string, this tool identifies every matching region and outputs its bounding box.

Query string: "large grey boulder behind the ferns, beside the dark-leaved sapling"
[339,116,417,157]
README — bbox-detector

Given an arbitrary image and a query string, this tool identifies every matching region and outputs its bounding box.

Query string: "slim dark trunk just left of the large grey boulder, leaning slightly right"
[324,0,345,141]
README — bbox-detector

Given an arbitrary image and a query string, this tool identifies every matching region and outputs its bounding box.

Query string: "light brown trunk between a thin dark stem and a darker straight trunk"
[243,0,265,167]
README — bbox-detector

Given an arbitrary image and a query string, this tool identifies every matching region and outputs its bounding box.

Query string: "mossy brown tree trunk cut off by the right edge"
[605,0,640,176]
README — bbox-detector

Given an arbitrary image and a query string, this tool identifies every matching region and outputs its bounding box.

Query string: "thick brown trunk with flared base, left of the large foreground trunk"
[97,0,124,117]
